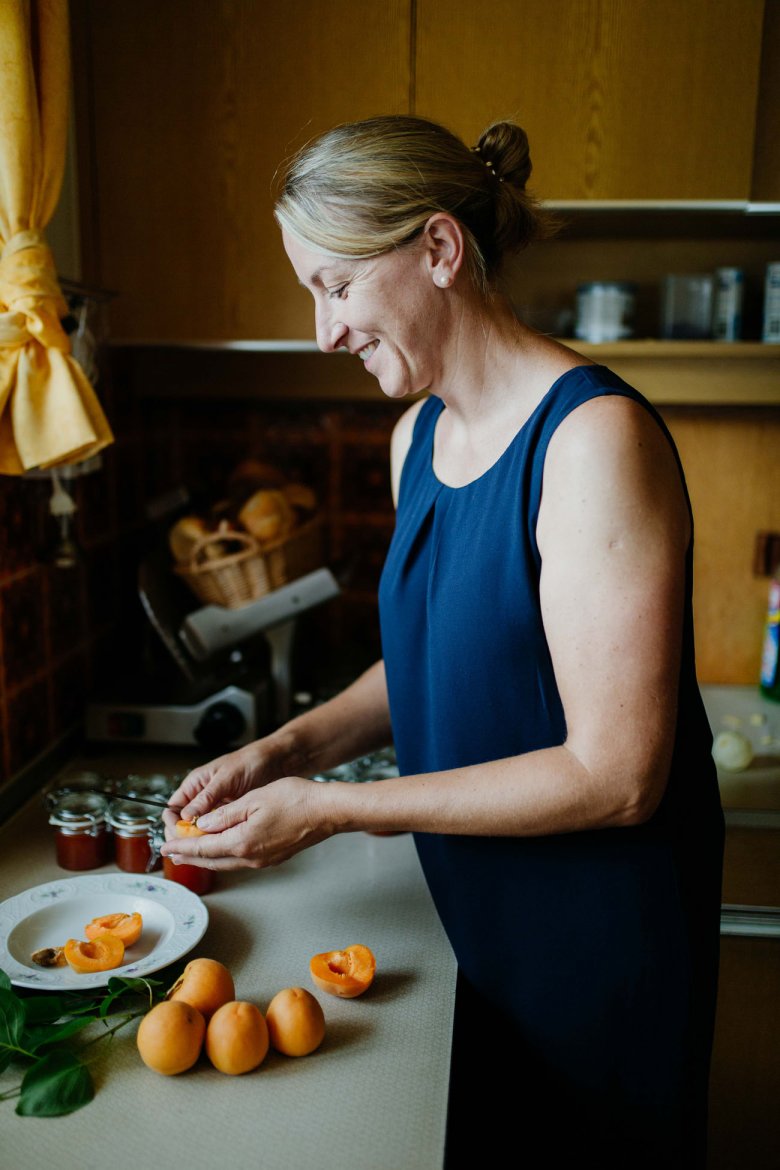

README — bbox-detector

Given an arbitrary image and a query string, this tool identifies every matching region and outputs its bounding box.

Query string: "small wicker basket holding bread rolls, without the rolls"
[175,517,323,610]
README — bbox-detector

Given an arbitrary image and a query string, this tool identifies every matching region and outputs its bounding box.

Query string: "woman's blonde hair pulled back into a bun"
[275,115,557,294]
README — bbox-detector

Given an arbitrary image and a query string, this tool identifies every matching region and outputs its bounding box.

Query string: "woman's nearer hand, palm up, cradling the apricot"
[161,776,336,869]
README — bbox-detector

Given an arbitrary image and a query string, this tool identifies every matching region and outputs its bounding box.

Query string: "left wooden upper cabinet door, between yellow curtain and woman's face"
[75,0,410,340]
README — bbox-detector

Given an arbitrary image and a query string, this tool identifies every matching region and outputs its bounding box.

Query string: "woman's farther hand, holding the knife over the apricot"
[163,739,284,840]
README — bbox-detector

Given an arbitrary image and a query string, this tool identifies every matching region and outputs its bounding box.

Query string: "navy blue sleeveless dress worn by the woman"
[379,365,723,1168]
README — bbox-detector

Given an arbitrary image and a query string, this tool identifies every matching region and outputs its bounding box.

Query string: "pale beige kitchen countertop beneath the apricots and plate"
[0,758,455,1170]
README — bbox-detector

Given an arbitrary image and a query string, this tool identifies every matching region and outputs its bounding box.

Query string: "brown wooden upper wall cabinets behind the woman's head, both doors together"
[71,0,780,342]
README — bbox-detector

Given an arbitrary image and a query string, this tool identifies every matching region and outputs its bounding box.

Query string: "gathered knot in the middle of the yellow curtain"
[0,229,70,353]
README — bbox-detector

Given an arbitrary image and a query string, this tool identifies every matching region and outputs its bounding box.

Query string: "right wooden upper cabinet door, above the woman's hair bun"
[415,0,764,199]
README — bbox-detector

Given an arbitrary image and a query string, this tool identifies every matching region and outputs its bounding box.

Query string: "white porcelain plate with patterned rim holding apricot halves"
[0,873,208,991]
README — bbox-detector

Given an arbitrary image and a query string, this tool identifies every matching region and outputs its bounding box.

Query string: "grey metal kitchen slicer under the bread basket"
[87,493,340,752]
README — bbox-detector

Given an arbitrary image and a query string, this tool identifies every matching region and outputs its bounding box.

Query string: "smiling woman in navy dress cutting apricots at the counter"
[165,117,723,1168]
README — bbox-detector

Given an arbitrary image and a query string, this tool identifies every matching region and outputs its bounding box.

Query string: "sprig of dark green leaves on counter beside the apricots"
[0,970,165,1117]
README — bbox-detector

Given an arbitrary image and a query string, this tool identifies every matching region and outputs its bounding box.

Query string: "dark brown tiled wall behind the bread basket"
[0,369,399,784]
